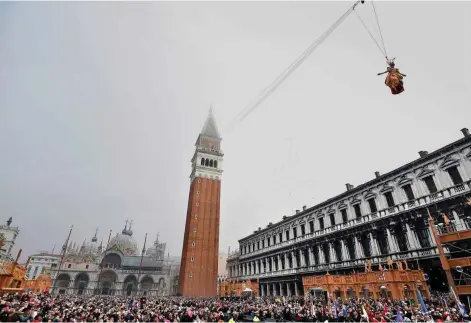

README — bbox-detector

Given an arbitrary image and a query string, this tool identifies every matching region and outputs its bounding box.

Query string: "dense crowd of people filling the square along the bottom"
[0,293,469,322]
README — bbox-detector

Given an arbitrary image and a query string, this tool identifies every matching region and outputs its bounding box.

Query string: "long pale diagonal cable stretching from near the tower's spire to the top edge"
[229,1,364,128]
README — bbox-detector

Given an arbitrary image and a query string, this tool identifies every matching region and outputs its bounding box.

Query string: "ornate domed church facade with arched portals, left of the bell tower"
[52,223,178,296]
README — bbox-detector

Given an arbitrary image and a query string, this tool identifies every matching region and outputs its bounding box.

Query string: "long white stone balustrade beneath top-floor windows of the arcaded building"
[239,181,471,260]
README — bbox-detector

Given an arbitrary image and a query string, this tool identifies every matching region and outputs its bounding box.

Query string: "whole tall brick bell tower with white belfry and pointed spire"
[178,109,224,296]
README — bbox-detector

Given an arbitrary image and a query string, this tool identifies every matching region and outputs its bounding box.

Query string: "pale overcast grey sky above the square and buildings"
[0,2,471,262]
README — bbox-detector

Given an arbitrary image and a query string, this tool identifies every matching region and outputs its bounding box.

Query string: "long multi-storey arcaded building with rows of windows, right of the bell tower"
[227,129,471,295]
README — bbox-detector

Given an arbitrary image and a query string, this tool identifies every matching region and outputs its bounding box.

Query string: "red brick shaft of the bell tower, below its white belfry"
[178,178,221,296]
